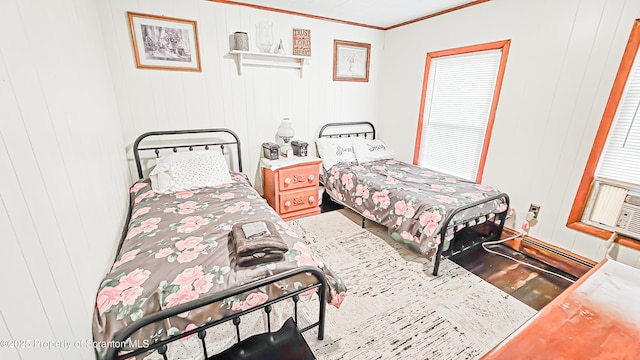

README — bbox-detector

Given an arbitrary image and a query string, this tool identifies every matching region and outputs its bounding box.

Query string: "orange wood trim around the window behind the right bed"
[413,40,511,183]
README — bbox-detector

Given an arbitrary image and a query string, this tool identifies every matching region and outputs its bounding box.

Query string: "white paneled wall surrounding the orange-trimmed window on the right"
[377,0,640,260]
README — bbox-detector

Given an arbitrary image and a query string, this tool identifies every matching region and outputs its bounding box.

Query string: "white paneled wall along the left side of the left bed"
[0,0,130,359]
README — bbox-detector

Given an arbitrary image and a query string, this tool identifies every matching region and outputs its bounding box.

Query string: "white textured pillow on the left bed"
[149,151,234,194]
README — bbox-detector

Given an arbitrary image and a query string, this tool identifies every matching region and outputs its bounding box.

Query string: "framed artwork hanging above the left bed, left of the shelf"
[127,12,202,71]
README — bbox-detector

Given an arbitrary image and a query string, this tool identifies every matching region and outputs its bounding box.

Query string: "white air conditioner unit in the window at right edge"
[582,179,640,240]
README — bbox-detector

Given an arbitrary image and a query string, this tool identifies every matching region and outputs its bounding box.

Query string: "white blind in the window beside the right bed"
[418,50,502,180]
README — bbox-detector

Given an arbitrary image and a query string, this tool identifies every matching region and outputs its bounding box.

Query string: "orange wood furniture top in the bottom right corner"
[482,259,640,360]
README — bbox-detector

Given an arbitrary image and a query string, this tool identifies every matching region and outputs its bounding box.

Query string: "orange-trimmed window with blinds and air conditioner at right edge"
[567,19,640,240]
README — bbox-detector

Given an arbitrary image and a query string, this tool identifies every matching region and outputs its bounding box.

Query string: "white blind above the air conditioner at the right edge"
[596,45,640,186]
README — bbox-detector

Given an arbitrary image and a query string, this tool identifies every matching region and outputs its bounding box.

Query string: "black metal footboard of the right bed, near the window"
[433,193,509,276]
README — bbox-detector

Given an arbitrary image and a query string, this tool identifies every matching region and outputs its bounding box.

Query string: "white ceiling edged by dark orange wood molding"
[211,0,488,29]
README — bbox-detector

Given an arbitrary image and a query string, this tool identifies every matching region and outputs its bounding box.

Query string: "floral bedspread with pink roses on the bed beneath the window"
[323,160,507,260]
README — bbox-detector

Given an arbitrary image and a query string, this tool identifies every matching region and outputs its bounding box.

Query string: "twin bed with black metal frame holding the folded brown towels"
[93,129,346,359]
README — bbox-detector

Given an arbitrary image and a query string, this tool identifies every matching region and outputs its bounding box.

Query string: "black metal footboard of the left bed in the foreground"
[105,266,328,360]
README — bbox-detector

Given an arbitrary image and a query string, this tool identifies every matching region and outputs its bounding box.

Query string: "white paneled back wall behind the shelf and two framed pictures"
[99,0,384,189]
